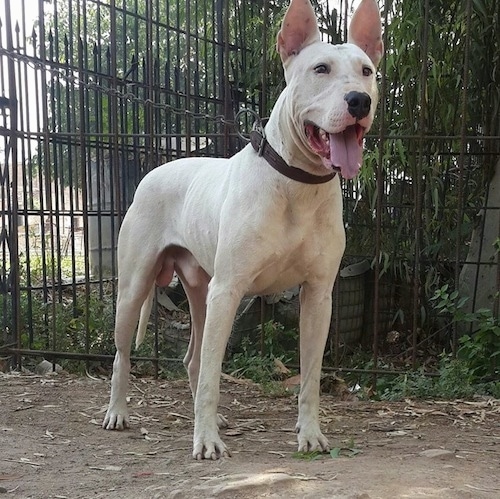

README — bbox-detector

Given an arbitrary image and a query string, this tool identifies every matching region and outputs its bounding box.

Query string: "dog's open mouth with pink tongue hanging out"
[305,123,365,179]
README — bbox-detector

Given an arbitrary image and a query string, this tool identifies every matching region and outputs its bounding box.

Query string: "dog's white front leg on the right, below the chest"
[296,283,332,452]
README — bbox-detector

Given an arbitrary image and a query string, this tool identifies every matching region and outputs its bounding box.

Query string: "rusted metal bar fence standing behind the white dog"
[0,0,500,378]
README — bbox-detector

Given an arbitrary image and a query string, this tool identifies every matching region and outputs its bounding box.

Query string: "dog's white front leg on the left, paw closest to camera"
[193,278,241,460]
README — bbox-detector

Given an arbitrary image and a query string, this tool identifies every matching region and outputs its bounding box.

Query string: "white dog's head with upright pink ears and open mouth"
[277,0,384,179]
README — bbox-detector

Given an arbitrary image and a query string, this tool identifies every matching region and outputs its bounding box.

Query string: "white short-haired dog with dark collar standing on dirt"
[103,0,383,459]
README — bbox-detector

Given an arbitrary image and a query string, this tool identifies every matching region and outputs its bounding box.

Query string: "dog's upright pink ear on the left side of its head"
[276,0,321,62]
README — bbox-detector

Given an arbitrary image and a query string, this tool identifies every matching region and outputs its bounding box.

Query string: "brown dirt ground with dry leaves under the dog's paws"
[0,373,500,499]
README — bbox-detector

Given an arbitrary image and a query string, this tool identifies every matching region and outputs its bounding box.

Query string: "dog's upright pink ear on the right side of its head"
[348,0,384,66]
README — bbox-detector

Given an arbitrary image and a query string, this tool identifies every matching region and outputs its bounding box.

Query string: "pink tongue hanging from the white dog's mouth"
[330,126,363,179]
